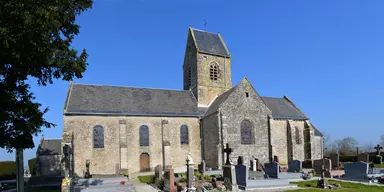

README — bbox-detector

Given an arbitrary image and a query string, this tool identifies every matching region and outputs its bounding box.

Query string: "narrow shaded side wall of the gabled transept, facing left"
[202,113,222,169]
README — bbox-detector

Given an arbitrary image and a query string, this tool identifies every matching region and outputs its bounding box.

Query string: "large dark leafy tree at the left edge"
[0,0,92,152]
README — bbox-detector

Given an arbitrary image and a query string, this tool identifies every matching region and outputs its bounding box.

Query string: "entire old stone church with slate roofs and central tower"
[62,28,323,177]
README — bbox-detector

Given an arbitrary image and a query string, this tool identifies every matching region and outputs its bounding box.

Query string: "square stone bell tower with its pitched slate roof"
[183,28,232,107]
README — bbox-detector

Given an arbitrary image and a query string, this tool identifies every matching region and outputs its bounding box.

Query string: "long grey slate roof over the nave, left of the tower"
[64,84,201,116]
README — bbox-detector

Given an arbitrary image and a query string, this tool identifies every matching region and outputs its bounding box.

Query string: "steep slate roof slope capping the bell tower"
[192,29,231,57]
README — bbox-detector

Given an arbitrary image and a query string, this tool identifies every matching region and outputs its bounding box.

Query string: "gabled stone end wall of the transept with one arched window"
[220,79,271,164]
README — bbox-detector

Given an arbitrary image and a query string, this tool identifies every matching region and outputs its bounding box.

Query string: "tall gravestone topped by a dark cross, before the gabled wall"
[223,143,237,191]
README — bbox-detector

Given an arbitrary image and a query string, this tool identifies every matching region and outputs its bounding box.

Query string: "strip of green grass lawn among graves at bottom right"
[289,180,384,192]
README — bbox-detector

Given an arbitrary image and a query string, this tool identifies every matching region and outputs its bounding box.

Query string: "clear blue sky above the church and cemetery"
[0,0,384,165]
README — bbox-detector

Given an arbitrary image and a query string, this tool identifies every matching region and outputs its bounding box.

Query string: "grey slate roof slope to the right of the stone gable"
[261,97,308,119]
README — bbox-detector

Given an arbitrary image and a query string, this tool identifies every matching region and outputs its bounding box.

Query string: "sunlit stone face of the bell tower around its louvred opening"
[197,53,232,106]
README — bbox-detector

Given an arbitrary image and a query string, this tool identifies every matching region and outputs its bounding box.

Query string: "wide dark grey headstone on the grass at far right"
[344,162,368,180]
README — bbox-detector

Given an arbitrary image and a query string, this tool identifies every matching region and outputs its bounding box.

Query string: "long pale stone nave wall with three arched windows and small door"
[64,116,201,177]
